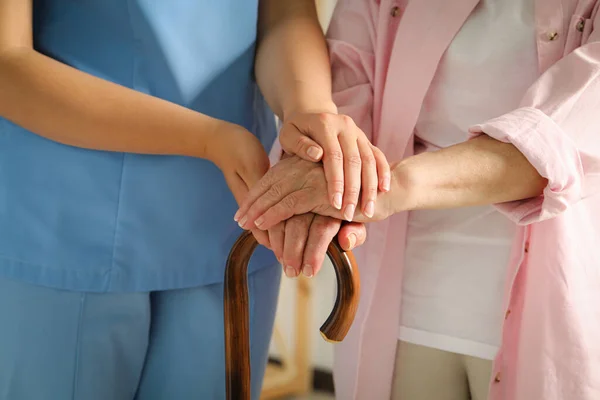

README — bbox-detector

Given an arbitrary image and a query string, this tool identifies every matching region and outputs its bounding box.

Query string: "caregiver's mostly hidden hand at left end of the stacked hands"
[206,121,270,248]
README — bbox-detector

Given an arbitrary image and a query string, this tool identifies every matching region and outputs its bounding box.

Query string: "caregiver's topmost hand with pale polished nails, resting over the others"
[279,112,390,221]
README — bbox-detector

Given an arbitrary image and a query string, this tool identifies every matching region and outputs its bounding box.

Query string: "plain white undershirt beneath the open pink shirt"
[399,0,538,359]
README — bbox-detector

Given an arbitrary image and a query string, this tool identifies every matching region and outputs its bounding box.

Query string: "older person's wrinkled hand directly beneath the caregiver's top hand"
[238,156,403,230]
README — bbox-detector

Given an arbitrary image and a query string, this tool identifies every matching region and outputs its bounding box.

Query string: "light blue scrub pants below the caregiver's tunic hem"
[0,266,281,400]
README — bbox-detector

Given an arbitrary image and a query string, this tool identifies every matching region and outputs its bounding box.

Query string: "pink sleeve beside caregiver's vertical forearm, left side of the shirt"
[327,0,379,138]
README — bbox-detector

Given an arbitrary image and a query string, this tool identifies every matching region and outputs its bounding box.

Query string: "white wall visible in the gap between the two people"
[271,0,337,369]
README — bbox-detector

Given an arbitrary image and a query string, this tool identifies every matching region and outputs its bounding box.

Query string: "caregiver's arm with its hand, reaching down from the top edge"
[256,0,390,220]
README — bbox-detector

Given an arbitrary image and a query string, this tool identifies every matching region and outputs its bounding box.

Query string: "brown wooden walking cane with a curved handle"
[224,231,360,400]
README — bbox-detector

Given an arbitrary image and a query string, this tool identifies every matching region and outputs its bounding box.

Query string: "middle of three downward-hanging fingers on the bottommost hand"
[283,213,315,278]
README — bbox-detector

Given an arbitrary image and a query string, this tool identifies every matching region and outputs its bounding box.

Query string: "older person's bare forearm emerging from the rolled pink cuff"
[392,135,547,212]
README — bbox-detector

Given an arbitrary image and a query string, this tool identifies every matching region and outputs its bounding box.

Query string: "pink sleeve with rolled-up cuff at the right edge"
[470,15,600,224]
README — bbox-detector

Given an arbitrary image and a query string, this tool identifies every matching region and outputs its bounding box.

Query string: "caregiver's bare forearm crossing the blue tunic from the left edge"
[0,48,222,157]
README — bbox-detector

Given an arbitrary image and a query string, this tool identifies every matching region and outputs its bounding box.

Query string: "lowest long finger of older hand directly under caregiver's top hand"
[255,189,318,230]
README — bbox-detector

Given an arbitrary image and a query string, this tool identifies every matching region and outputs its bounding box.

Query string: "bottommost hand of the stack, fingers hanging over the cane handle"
[269,213,367,278]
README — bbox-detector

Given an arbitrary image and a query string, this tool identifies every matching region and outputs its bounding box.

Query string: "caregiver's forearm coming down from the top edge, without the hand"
[255,0,337,119]
